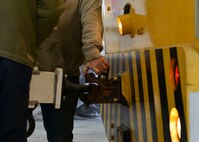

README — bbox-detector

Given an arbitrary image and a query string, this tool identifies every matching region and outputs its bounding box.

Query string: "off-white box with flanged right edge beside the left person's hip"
[29,68,63,109]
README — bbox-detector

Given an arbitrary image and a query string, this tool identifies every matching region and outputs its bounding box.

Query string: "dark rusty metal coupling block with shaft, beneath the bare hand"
[64,73,128,106]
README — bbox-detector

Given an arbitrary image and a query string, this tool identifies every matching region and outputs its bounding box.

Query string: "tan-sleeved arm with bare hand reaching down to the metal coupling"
[80,0,110,74]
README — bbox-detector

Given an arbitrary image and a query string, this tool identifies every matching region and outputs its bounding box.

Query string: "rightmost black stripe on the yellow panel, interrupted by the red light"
[170,47,187,142]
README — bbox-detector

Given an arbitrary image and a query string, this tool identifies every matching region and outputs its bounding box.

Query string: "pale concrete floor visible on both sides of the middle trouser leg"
[28,110,108,142]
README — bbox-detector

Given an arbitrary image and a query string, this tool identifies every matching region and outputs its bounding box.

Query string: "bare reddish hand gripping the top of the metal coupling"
[83,56,110,75]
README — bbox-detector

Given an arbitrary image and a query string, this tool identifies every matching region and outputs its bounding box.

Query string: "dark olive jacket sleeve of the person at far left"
[36,0,65,45]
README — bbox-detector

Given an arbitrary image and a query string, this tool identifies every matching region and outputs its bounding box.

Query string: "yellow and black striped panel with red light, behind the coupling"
[101,47,187,142]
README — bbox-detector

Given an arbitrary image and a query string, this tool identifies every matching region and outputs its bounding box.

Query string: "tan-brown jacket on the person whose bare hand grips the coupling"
[38,0,103,76]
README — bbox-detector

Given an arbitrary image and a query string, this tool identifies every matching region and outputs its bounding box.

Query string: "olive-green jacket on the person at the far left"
[0,0,64,67]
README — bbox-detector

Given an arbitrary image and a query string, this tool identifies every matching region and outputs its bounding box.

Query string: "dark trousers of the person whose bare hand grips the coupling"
[41,77,79,142]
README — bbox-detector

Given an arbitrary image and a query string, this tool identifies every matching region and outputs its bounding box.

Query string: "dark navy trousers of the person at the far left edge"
[0,57,32,142]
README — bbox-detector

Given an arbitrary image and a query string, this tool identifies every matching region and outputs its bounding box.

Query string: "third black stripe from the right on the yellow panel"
[145,50,158,142]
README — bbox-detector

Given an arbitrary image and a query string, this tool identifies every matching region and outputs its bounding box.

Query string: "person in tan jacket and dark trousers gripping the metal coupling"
[37,0,109,142]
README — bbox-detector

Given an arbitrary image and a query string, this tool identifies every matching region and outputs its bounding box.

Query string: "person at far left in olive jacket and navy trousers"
[0,0,64,142]
